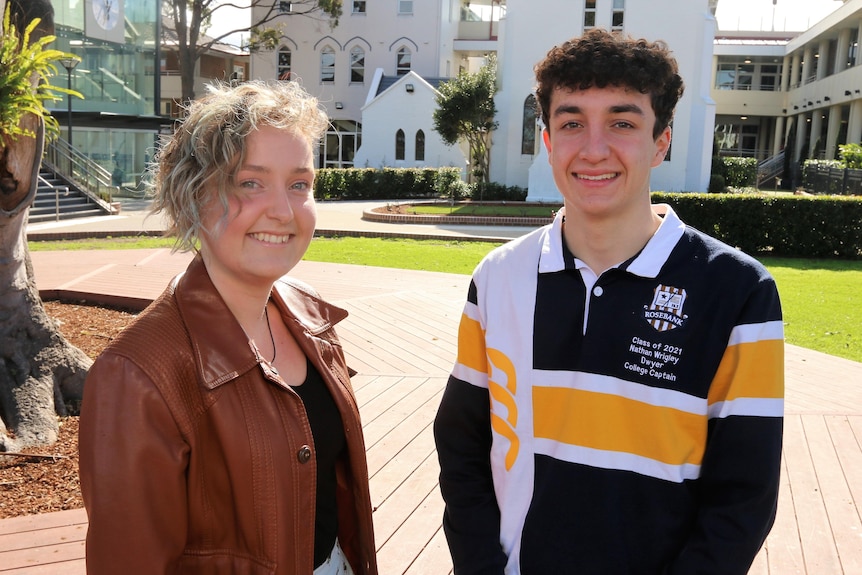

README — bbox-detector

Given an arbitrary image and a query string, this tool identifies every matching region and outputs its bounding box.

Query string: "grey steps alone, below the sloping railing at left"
[27,168,110,224]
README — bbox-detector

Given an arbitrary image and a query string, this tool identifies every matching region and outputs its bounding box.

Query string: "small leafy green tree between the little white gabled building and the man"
[434,55,497,183]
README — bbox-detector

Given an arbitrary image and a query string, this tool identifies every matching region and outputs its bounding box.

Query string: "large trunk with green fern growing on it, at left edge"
[0,0,91,452]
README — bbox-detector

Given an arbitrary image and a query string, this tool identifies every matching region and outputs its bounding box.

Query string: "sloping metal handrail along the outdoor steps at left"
[42,138,119,213]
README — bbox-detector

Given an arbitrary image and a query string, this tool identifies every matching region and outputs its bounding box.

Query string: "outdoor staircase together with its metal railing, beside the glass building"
[27,138,117,224]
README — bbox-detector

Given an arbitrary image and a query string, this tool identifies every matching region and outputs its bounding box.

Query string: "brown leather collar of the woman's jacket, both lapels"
[171,255,347,389]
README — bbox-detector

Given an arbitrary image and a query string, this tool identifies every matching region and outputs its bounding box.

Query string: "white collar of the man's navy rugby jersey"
[539,204,685,278]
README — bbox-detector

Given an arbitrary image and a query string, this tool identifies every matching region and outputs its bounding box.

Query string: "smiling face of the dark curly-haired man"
[544,87,670,223]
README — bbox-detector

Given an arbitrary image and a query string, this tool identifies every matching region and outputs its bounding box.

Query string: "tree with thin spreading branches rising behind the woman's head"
[162,0,342,102]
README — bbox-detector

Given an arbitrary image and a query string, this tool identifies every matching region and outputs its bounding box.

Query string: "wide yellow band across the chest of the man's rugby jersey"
[533,387,707,465]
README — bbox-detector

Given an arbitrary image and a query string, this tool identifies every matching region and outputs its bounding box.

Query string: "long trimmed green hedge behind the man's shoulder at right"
[652,192,862,259]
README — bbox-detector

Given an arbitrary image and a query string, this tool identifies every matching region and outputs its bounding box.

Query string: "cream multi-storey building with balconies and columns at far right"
[712,0,862,189]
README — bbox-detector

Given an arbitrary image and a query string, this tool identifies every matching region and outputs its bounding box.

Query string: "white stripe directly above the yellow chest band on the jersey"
[533,370,707,415]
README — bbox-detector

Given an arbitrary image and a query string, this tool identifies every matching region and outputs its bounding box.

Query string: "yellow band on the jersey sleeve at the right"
[709,339,784,405]
